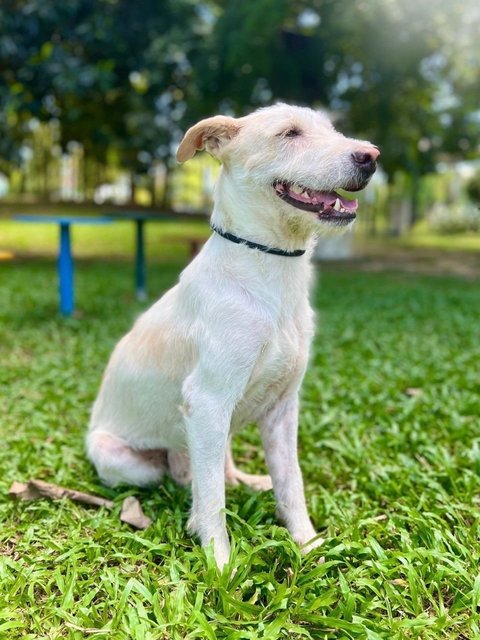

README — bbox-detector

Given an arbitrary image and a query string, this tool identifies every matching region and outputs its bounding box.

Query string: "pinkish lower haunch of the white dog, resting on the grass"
[87,430,168,487]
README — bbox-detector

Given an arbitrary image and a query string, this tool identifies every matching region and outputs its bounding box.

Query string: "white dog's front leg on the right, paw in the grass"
[260,394,323,552]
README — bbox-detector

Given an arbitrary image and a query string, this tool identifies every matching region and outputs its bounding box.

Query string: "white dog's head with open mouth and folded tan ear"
[177,104,380,234]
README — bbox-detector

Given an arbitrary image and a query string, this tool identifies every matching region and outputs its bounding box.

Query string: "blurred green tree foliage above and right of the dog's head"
[193,0,480,230]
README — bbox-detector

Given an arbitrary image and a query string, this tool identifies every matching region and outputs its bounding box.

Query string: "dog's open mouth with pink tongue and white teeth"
[273,180,358,224]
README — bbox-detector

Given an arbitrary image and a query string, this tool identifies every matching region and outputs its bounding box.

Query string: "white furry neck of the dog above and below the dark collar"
[199,170,315,321]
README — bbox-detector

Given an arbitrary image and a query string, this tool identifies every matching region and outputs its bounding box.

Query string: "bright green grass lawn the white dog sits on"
[0,238,480,640]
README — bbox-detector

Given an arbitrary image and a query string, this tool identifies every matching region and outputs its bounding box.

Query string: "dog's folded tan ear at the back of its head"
[177,116,240,162]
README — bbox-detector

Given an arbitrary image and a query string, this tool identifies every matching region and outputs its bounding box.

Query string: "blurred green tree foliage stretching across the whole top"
[0,0,480,198]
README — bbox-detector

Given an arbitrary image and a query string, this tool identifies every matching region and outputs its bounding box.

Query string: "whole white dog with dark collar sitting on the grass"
[87,104,379,567]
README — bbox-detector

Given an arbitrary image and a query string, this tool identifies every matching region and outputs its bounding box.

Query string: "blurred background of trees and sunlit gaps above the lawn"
[0,0,480,262]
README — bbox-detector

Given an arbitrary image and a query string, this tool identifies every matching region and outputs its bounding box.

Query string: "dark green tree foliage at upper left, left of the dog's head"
[0,0,199,170]
